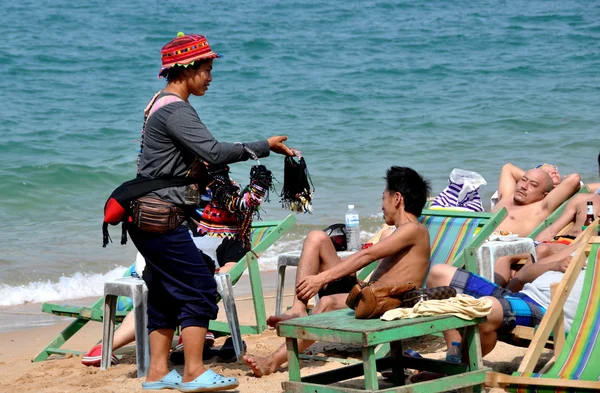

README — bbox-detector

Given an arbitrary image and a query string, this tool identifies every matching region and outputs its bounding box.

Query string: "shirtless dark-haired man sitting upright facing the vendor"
[244,166,430,377]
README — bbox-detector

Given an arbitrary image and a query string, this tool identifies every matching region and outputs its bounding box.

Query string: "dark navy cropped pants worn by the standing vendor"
[129,225,219,333]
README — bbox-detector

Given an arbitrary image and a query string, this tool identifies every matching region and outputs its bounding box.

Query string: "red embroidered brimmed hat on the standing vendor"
[158,32,222,78]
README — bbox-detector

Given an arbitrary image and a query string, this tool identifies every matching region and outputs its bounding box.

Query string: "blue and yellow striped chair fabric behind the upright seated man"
[419,215,482,266]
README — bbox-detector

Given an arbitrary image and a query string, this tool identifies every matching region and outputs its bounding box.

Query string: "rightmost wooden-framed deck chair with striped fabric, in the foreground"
[486,220,600,392]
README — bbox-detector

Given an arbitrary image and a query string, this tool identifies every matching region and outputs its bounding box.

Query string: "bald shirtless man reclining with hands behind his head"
[493,164,580,237]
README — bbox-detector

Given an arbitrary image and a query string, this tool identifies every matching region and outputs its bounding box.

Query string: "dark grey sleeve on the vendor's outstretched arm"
[167,105,270,165]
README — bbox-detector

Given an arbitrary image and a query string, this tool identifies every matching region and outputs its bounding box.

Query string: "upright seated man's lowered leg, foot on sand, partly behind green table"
[244,293,348,377]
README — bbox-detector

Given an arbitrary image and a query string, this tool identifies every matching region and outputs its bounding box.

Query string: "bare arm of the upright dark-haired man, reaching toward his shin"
[296,223,419,299]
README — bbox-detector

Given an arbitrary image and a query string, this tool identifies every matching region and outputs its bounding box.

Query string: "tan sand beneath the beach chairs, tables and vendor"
[0,269,548,393]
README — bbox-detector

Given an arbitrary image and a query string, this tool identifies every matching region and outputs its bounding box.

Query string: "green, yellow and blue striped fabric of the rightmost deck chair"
[507,244,600,393]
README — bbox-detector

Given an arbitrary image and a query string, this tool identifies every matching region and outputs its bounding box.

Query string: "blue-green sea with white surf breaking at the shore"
[0,0,600,312]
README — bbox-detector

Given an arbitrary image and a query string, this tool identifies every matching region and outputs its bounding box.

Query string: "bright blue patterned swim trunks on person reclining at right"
[450,269,546,331]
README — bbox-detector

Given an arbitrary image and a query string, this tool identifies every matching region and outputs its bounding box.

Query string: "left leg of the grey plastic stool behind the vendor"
[133,285,150,378]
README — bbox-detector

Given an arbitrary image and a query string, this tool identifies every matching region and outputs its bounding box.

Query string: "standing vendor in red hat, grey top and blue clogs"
[128,33,293,392]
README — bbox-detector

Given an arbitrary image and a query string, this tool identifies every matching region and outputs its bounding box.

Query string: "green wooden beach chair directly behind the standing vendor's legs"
[32,215,296,362]
